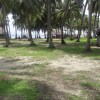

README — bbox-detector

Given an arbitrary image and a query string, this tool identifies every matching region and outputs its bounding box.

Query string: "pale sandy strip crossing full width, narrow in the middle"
[0,55,100,73]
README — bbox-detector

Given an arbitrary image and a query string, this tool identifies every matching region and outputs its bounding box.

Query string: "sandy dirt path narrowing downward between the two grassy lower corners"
[0,55,100,100]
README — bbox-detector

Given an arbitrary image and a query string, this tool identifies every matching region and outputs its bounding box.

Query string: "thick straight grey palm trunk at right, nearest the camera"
[85,0,93,51]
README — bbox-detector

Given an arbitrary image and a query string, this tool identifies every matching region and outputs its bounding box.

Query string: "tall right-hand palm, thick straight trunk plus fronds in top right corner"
[86,0,100,51]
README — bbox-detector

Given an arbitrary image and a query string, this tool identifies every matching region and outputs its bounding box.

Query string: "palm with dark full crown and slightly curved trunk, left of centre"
[13,0,39,45]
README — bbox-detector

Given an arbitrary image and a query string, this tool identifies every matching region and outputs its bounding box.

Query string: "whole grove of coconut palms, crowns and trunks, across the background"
[0,0,100,51]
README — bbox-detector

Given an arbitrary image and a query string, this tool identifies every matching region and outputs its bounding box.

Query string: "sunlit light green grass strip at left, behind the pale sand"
[0,40,63,59]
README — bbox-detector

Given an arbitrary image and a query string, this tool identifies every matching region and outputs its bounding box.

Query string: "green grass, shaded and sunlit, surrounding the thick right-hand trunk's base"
[59,38,100,59]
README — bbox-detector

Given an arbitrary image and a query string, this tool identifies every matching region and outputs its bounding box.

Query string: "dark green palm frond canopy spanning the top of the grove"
[0,0,100,49]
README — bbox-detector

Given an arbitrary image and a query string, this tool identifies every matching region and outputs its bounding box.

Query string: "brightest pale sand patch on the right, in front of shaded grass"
[50,55,100,74]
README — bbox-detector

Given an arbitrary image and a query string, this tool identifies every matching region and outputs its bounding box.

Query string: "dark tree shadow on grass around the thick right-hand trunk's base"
[57,43,100,59]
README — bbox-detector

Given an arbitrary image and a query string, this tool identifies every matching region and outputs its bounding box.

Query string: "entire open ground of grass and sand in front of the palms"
[0,40,100,100]
